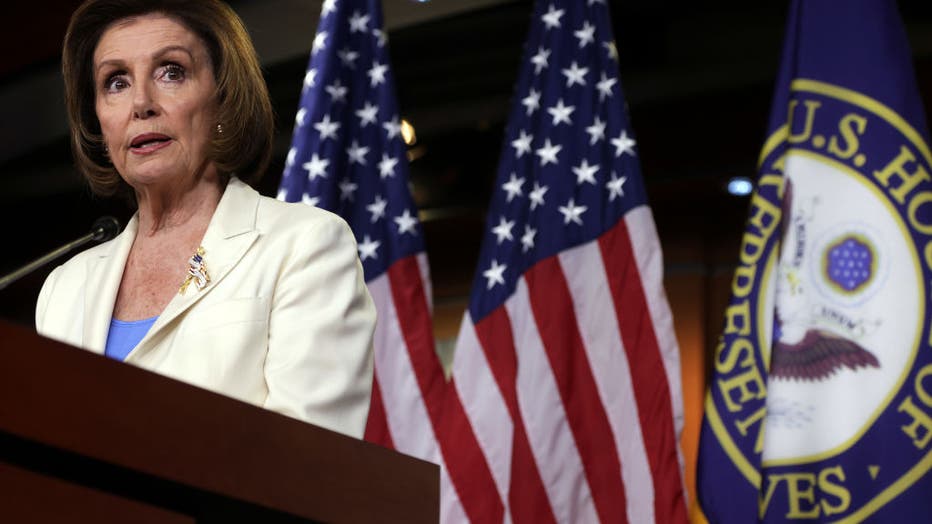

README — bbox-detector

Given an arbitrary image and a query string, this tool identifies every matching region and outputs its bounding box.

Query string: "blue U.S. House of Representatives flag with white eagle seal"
[699,0,932,523]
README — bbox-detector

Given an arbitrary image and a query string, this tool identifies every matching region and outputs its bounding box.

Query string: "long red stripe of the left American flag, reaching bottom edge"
[388,256,504,522]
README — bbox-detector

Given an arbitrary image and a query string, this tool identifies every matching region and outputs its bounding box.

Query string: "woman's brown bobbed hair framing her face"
[62,0,275,196]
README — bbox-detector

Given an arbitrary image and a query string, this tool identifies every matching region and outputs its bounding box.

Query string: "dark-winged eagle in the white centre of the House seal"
[770,177,880,381]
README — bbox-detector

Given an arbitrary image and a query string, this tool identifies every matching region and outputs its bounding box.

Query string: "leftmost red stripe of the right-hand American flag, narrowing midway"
[475,307,556,523]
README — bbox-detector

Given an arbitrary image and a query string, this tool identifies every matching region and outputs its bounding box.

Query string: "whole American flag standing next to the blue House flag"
[442,0,686,523]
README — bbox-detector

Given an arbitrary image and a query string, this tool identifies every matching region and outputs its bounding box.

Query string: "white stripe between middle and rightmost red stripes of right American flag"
[559,240,656,522]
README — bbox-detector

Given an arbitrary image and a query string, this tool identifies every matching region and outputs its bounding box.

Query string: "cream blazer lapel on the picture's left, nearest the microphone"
[82,215,139,354]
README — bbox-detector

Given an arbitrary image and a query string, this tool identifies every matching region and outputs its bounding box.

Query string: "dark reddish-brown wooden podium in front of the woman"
[0,321,440,524]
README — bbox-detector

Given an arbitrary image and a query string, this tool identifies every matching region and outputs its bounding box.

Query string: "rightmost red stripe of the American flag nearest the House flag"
[599,220,687,522]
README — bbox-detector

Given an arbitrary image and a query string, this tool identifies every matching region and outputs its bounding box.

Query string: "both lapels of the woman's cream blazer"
[84,177,261,361]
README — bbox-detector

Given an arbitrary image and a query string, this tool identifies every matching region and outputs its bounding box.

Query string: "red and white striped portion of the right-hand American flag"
[453,208,686,522]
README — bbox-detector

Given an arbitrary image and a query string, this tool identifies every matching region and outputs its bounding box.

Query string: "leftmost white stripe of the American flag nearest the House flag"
[452,311,514,512]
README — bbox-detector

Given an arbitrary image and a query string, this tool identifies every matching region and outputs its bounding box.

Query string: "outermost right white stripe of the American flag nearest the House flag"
[625,206,687,472]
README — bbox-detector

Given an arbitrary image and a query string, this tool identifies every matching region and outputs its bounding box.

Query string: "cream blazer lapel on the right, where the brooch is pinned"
[126,177,260,361]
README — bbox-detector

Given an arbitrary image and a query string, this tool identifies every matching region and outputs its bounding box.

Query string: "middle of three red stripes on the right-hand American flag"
[524,257,628,522]
